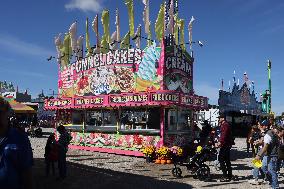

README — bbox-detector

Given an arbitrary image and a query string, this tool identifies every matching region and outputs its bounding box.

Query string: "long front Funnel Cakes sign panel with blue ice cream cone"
[58,43,164,97]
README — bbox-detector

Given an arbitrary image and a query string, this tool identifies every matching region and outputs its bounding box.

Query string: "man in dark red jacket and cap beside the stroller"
[217,113,232,182]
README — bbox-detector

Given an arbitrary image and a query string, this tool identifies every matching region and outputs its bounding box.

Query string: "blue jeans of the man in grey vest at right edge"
[267,156,279,189]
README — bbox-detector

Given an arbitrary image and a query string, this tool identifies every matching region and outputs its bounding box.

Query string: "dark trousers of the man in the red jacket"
[219,147,232,179]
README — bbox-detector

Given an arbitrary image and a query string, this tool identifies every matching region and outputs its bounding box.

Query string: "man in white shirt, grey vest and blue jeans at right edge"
[255,126,284,189]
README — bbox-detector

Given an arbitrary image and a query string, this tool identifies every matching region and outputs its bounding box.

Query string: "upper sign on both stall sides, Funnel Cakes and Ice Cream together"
[58,43,193,97]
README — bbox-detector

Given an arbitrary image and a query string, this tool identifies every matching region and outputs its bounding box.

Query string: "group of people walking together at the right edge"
[247,119,284,189]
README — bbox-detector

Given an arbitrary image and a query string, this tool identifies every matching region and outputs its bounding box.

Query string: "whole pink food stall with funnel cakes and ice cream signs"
[45,2,208,156]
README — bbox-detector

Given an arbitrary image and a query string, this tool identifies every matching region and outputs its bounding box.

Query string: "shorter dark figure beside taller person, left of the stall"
[44,134,58,176]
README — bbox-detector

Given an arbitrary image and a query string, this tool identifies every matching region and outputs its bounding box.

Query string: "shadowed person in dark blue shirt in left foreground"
[0,97,33,189]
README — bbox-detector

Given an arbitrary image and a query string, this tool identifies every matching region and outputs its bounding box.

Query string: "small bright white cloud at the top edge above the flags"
[65,0,103,12]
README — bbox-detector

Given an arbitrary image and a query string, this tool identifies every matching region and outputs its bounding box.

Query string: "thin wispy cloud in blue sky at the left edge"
[0,33,55,57]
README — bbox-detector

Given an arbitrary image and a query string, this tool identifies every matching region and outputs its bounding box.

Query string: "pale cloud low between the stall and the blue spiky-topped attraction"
[194,83,219,104]
